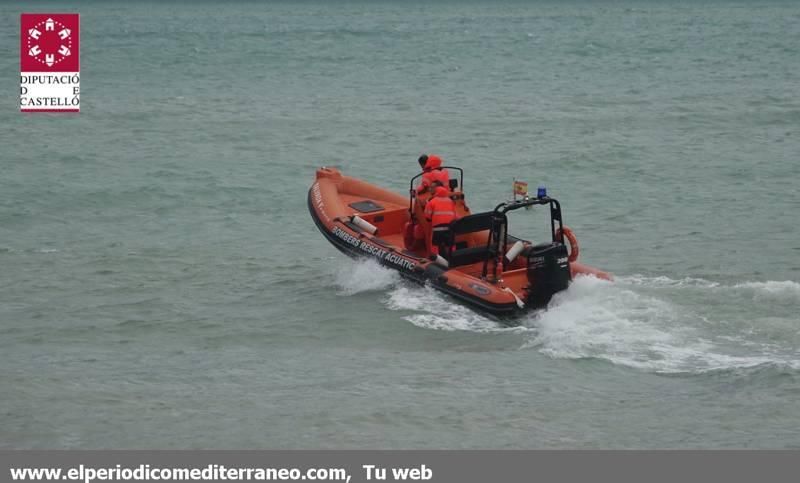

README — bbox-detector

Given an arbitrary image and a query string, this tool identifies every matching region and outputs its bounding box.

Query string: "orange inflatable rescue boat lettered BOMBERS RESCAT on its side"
[308,166,611,317]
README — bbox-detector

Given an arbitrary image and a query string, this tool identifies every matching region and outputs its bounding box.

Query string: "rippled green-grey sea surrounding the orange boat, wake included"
[0,0,800,448]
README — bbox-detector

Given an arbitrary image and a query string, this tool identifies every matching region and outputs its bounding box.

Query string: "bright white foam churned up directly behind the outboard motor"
[524,277,800,373]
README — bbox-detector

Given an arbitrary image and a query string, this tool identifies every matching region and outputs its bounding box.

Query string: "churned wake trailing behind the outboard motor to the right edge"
[524,276,800,373]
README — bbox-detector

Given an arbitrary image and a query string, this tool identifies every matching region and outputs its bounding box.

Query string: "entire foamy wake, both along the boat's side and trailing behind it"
[337,261,800,374]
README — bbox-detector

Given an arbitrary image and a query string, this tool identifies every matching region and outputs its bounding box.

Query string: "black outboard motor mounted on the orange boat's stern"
[524,243,572,308]
